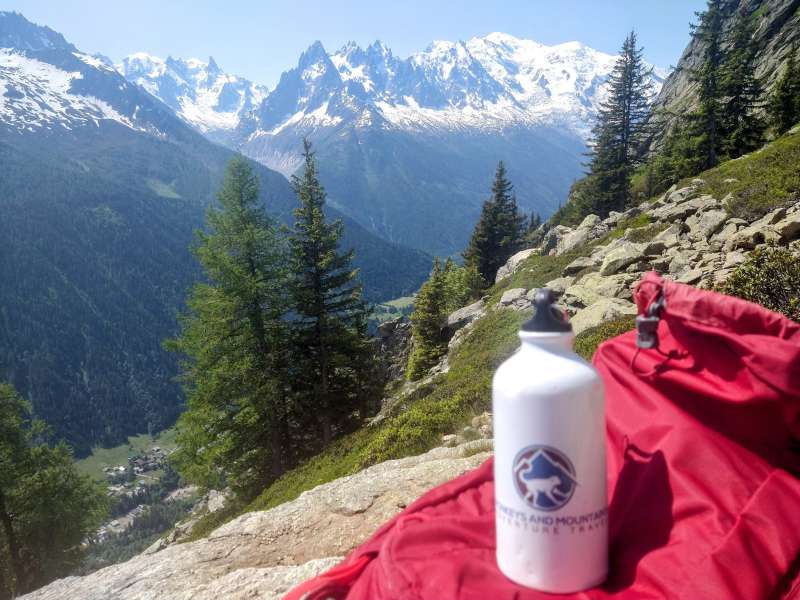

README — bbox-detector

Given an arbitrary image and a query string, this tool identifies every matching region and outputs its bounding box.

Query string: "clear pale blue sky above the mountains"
[6,0,705,86]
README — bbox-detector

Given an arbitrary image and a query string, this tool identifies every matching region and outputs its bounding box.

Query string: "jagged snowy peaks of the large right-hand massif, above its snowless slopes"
[234,33,664,152]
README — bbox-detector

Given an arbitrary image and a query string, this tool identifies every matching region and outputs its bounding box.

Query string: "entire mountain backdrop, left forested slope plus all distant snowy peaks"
[0,12,658,454]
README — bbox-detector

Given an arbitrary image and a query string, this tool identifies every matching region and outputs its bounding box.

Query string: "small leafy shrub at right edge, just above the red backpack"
[721,247,800,321]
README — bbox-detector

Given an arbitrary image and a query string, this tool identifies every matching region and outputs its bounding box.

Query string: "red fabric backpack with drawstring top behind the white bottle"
[286,273,800,600]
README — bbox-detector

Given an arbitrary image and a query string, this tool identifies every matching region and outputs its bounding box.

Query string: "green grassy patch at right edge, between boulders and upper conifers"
[678,132,800,220]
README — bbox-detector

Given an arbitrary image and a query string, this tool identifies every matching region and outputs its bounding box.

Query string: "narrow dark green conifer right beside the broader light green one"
[289,140,370,444]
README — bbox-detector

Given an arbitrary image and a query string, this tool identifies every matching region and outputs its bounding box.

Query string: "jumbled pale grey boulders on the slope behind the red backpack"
[482,179,800,334]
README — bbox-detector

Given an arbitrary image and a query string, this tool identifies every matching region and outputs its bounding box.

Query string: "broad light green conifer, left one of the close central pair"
[166,157,290,497]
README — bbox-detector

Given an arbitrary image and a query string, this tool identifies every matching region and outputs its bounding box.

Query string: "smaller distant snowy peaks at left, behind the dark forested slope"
[116,52,268,142]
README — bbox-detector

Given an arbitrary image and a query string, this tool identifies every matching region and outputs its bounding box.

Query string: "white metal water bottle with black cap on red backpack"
[492,289,608,593]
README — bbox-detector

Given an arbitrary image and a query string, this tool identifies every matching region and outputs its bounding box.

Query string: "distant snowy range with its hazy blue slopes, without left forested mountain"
[118,33,663,255]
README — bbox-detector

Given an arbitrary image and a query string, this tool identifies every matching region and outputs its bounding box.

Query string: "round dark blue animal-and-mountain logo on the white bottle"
[513,446,578,511]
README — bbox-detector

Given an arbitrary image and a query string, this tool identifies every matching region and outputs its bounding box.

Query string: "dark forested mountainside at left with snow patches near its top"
[0,12,430,454]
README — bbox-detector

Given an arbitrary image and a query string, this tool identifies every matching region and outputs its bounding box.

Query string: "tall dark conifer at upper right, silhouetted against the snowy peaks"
[585,31,650,217]
